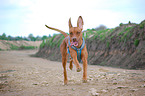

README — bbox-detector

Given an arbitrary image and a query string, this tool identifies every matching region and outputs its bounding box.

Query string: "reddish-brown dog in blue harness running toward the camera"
[45,16,88,84]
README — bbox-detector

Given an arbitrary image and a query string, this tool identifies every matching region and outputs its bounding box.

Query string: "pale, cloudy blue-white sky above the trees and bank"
[0,0,145,37]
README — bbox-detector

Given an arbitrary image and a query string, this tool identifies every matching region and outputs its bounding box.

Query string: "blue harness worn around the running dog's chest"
[67,38,85,62]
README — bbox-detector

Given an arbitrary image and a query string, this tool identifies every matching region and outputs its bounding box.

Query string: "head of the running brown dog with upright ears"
[69,16,84,46]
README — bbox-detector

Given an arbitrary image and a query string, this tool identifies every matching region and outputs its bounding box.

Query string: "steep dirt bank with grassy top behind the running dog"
[36,20,145,69]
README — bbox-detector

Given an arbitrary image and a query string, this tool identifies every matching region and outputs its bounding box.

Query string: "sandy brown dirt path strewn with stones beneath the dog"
[0,50,145,96]
